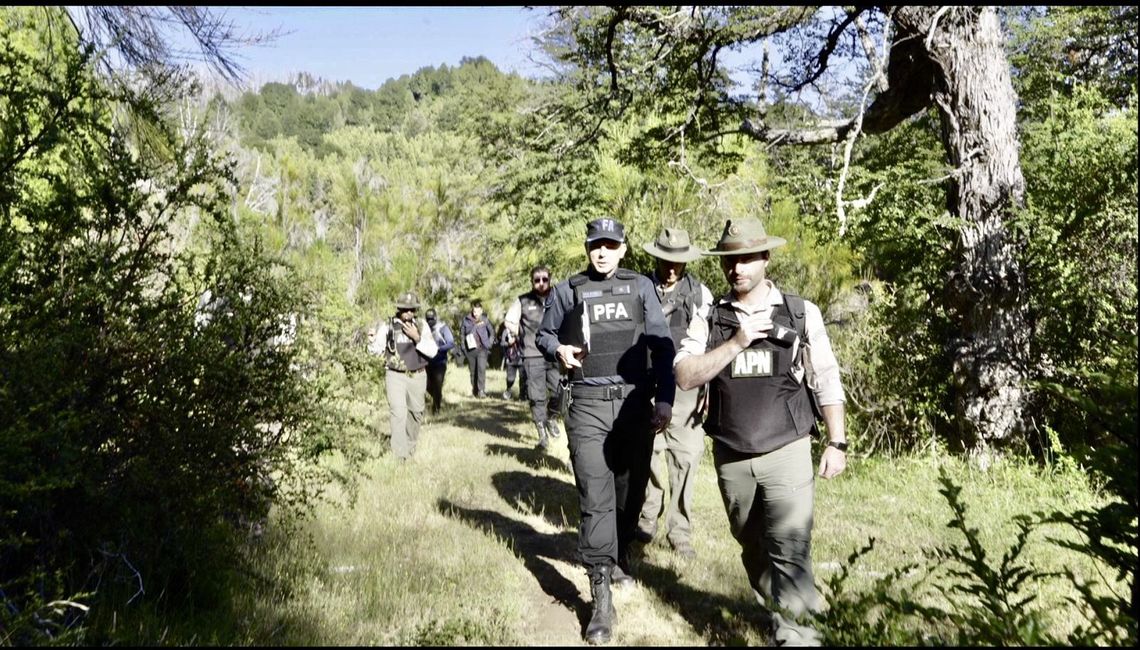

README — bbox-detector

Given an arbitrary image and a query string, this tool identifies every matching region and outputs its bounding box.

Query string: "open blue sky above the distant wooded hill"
[218,7,544,89]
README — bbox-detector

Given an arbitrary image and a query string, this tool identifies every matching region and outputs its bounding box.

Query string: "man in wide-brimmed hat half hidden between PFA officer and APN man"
[636,228,713,558]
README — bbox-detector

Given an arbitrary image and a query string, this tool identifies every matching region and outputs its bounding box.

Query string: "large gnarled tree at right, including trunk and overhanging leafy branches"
[533,6,1029,453]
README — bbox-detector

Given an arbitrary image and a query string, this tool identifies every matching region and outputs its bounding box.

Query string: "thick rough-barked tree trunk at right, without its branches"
[895,7,1029,461]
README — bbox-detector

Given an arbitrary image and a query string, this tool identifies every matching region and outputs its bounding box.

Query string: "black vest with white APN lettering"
[705,302,815,454]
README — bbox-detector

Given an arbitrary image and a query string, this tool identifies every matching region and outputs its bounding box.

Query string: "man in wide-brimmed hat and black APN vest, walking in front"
[676,218,847,645]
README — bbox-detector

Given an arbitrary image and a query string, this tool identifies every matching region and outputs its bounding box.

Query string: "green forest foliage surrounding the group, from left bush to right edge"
[0,3,1138,642]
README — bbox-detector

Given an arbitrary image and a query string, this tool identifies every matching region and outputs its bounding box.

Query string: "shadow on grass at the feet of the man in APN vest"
[635,551,771,645]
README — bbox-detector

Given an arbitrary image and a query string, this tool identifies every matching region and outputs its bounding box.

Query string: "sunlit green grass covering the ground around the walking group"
[108,367,1110,645]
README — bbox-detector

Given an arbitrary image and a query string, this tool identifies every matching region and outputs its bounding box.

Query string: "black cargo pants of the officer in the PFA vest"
[565,384,653,568]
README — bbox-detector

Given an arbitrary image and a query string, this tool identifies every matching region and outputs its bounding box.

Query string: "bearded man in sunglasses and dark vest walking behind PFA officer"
[503,265,562,449]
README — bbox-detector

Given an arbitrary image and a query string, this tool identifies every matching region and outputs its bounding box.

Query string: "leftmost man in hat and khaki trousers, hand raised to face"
[369,292,439,461]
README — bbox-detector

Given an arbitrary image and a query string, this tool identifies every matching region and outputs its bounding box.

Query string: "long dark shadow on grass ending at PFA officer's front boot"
[437,494,591,629]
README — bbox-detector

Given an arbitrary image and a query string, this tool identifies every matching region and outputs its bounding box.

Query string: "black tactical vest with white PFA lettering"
[559,268,649,383]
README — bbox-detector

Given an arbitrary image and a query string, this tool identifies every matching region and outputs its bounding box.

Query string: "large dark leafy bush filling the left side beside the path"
[0,16,362,644]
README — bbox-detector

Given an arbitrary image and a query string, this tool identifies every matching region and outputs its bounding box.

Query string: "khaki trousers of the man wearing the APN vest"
[713,436,822,645]
